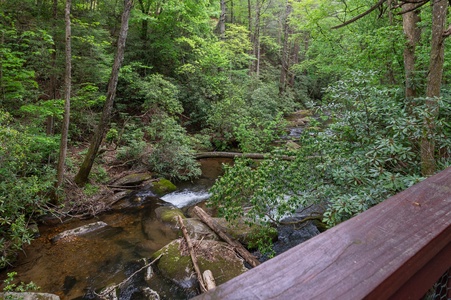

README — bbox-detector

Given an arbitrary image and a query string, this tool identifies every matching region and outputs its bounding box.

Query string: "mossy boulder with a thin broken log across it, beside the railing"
[152,239,247,289]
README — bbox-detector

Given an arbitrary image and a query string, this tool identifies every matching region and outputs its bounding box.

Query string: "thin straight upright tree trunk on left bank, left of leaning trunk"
[55,0,72,195]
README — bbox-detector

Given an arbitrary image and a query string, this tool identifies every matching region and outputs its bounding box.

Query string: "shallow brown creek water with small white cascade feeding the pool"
[0,159,231,299]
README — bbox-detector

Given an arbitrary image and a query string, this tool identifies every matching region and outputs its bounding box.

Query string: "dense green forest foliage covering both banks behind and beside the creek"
[0,0,451,268]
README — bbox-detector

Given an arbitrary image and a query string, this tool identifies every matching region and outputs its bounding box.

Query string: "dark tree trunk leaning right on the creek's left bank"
[75,0,133,186]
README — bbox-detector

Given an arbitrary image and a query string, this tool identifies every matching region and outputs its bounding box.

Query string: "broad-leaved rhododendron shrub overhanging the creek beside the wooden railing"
[210,73,450,254]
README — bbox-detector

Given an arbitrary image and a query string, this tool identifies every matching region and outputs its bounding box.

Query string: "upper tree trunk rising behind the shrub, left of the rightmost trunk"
[402,3,421,101]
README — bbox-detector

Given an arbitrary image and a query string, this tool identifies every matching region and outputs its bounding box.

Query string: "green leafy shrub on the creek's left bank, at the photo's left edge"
[0,111,57,269]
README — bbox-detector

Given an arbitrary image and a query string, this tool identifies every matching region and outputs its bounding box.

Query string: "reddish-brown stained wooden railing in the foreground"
[196,168,451,300]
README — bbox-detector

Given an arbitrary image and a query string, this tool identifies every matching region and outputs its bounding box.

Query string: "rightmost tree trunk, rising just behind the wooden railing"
[421,0,448,176]
